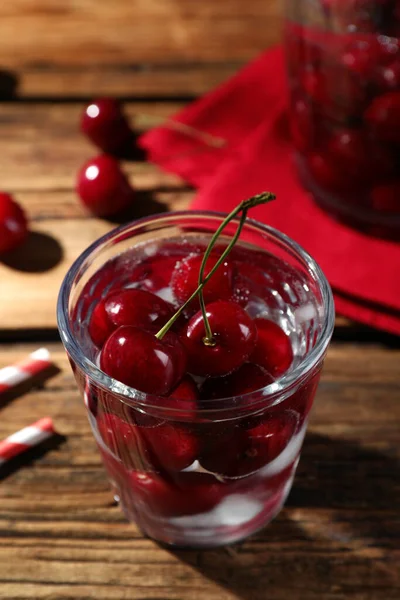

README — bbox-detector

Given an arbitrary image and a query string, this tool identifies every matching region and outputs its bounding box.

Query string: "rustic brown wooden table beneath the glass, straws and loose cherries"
[0,0,400,600]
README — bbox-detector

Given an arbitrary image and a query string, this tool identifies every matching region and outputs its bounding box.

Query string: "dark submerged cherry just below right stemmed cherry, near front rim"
[201,363,274,400]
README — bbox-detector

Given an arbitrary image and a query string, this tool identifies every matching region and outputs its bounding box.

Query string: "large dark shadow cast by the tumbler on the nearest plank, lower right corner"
[170,433,400,600]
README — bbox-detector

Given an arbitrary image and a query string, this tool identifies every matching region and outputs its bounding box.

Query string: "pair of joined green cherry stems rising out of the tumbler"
[156,192,276,345]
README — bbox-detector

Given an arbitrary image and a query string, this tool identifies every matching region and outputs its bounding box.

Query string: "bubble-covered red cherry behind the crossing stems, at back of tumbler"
[171,254,233,308]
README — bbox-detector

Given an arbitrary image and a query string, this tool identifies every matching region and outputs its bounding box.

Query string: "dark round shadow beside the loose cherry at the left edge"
[1,231,64,273]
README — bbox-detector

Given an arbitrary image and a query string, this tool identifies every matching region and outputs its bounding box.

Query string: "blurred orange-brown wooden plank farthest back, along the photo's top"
[0,0,282,97]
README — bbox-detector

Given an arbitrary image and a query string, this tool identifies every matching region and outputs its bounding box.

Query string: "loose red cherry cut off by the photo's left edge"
[0,192,28,254]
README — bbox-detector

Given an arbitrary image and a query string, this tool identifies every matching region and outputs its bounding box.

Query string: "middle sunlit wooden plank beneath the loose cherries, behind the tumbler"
[0,102,193,330]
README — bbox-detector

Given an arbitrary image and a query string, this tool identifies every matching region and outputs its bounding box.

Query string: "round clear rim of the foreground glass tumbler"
[57,210,335,413]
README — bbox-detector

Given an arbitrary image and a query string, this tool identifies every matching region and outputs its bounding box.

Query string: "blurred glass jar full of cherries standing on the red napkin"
[285,0,400,239]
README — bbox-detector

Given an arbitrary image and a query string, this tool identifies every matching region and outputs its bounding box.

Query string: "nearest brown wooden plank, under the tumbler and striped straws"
[0,343,400,600]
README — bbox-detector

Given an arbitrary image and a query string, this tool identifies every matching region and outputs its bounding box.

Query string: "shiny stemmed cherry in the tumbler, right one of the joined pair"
[181,300,257,376]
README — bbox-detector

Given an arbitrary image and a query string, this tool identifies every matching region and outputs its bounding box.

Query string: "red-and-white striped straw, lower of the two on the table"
[0,417,55,466]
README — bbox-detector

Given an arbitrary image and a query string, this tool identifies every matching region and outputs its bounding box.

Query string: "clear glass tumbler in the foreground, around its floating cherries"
[58,212,334,547]
